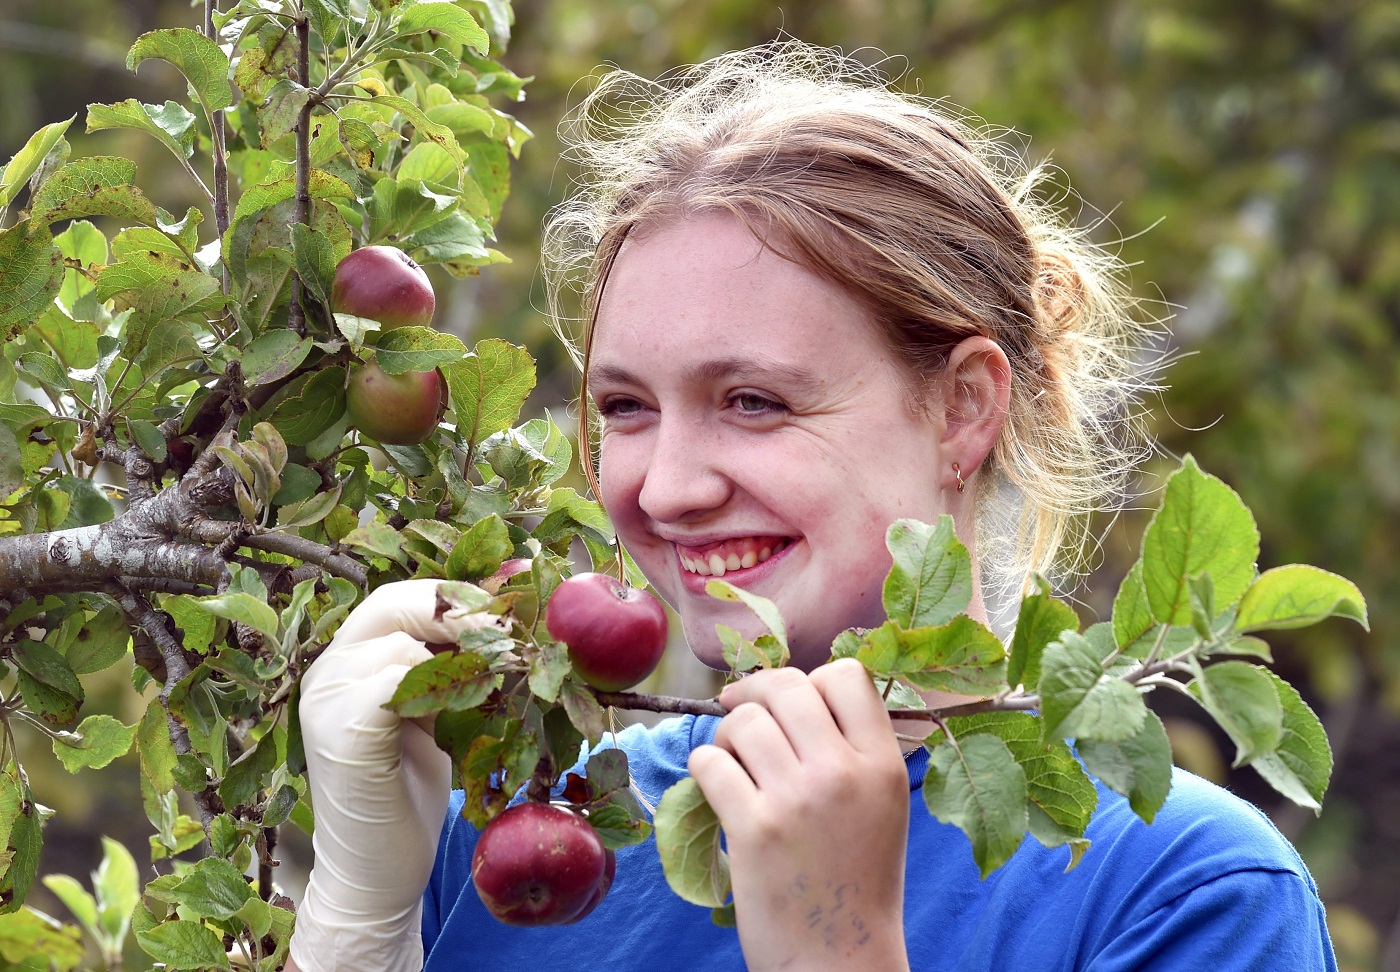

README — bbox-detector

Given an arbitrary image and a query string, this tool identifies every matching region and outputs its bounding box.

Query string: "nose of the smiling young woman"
[637,416,732,522]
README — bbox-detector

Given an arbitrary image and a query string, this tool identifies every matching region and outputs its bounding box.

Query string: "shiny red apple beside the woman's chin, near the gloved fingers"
[545,574,666,692]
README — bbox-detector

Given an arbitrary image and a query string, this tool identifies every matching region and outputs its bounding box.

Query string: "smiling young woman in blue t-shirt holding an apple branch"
[284,43,1334,972]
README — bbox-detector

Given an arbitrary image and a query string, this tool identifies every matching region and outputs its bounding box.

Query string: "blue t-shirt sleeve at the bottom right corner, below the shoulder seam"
[1086,868,1337,972]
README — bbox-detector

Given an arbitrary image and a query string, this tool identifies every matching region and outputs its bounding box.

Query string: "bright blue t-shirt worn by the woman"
[423,716,1337,972]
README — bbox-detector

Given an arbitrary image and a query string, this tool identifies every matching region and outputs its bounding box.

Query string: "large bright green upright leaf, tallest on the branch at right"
[1142,455,1259,625]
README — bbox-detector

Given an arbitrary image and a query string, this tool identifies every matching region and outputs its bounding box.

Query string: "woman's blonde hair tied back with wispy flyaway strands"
[545,41,1152,593]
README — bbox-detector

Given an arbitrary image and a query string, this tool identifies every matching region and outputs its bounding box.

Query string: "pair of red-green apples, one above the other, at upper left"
[330,247,447,445]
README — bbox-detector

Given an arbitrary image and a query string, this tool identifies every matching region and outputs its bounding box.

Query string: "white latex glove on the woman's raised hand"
[291,580,494,972]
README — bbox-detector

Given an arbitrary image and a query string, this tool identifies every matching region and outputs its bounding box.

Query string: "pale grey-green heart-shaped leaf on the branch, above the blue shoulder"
[1039,632,1147,742]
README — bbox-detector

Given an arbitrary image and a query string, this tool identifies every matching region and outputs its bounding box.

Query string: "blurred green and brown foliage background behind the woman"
[0,0,1400,971]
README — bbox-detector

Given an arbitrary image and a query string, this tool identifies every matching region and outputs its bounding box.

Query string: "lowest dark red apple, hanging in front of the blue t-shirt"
[472,803,616,927]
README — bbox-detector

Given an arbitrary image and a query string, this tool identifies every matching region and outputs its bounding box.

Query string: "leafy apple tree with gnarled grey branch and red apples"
[0,0,1365,971]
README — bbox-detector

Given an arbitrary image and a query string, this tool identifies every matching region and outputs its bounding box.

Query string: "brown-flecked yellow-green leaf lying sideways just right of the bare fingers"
[854,615,1007,695]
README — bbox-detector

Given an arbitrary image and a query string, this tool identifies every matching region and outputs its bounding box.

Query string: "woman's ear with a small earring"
[941,336,1011,479]
